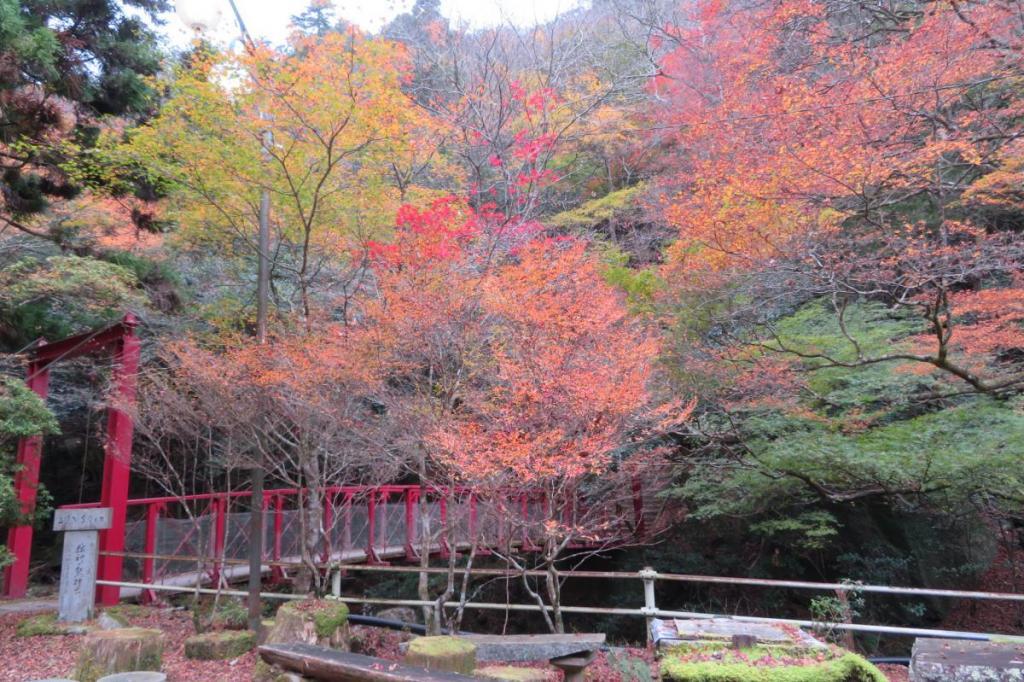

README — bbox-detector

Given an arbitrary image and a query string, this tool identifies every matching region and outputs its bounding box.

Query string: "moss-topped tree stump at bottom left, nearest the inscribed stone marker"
[75,628,164,682]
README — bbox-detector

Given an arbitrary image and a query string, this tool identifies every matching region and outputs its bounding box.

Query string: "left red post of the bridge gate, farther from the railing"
[3,356,50,597]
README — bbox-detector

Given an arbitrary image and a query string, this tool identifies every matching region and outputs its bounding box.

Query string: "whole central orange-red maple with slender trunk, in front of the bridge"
[367,199,688,631]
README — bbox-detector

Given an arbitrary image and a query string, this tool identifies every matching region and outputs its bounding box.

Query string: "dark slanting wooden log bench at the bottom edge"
[257,644,476,682]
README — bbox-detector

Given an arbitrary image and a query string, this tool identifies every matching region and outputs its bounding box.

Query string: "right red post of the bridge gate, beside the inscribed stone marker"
[96,314,139,606]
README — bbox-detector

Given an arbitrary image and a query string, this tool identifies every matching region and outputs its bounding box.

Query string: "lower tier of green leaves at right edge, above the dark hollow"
[681,398,1024,518]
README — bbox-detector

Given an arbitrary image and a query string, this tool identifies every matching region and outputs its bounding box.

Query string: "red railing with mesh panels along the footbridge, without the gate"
[65,484,643,599]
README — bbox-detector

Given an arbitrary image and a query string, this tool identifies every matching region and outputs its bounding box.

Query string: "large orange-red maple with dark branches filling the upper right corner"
[653,0,1024,393]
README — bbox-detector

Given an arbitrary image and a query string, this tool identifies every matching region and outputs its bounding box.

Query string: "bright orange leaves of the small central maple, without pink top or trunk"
[433,237,657,482]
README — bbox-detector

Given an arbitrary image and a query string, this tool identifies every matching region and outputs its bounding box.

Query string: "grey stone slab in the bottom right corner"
[910,638,1024,682]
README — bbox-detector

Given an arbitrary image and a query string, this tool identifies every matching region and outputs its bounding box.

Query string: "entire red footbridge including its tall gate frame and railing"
[3,314,647,605]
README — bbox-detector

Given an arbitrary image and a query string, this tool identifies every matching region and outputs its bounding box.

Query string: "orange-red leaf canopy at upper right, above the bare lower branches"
[655,0,1020,272]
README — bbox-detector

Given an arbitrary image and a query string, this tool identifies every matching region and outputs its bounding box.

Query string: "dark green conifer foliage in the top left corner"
[0,0,168,217]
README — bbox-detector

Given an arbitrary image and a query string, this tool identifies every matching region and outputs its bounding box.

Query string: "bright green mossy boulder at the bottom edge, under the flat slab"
[662,647,886,682]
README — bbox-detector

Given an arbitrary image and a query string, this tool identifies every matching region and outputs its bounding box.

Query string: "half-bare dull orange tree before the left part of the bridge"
[134,326,402,593]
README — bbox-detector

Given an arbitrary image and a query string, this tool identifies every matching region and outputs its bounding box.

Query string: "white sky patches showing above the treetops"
[164,0,581,46]
